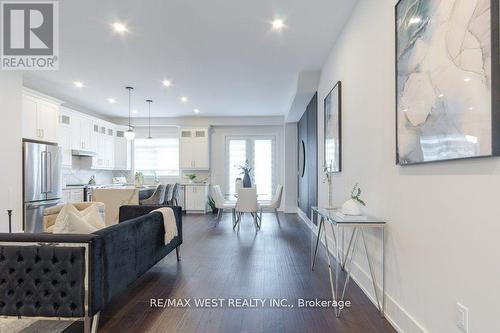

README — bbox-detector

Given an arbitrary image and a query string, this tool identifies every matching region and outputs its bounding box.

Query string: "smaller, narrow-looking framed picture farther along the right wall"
[324,81,342,172]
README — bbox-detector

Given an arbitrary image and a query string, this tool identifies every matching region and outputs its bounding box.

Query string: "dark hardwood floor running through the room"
[72,214,395,333]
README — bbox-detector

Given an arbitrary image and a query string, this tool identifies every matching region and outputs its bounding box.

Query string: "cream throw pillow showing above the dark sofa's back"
[54,204,104,234]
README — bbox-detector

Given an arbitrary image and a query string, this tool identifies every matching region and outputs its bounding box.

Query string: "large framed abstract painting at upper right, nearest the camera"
[396,0,500,165]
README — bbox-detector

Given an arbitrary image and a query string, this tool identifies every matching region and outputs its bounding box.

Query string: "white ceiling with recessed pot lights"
[24,0,356,117]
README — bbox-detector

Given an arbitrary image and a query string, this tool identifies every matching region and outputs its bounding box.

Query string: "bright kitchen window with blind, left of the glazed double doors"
[134,138,179,176]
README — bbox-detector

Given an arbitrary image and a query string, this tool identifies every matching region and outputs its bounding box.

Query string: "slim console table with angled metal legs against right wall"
[311,207,386,317]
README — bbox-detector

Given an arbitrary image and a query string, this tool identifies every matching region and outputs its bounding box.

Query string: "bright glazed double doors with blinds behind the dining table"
[226,137,275,199]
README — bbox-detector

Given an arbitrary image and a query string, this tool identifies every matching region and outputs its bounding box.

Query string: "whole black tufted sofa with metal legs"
[0,206,182,332]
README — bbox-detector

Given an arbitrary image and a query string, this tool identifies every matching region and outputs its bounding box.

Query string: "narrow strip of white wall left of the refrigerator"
[0,71,23,232]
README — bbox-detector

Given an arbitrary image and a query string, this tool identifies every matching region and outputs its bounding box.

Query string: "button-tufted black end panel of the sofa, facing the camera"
[0,234,102,318]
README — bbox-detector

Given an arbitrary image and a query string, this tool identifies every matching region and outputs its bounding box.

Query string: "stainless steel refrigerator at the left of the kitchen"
[23,142,62,233]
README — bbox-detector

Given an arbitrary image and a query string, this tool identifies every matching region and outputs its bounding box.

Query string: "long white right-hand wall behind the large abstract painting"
[318,0,500,332]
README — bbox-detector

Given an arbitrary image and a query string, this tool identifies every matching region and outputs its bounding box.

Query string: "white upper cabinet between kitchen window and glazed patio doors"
[180,128,210,170]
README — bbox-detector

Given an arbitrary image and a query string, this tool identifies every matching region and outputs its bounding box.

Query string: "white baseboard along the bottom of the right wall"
[297,209,429,333]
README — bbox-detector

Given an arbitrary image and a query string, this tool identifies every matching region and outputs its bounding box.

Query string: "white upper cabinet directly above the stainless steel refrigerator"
[23,89,61,142]
